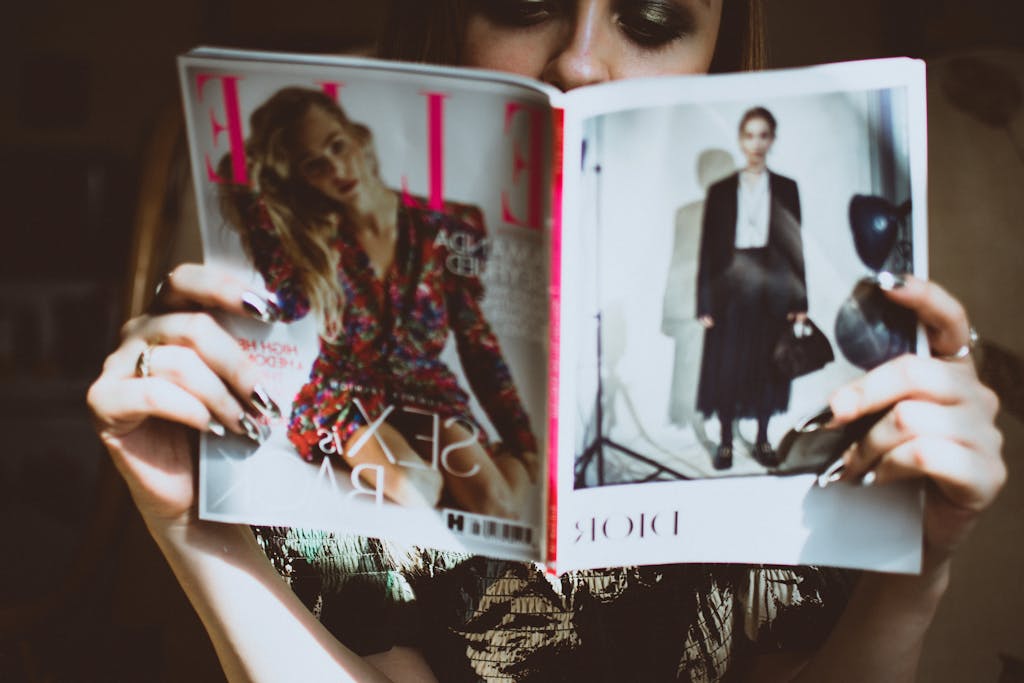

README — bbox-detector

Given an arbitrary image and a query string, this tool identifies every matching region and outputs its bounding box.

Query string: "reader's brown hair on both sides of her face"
[378,0,767,73]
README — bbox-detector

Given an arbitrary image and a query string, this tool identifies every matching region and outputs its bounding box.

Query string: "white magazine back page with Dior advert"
[556,59,928,571]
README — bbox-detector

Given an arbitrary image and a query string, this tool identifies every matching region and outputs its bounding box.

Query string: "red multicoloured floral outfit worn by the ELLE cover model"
[246,201,537,461]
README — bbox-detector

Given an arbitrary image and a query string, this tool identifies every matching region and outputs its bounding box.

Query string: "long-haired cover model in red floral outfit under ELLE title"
[214,87,537,517]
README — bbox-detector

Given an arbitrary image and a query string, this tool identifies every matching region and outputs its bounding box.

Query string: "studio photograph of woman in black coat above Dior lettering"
[575,88,927,487]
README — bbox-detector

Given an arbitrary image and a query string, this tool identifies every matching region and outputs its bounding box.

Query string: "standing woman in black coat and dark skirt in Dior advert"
[697,106,807,469]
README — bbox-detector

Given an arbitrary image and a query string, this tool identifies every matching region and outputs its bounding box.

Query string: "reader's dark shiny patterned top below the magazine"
[254,527,855,683]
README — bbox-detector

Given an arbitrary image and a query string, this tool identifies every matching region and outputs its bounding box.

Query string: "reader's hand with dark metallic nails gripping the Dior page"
[829,276,1007,563]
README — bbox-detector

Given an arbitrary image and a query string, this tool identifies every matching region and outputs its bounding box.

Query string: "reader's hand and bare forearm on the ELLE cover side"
[89,265,411,682]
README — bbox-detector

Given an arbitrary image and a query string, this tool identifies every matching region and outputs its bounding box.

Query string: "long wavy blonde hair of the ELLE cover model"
[220,87,378,340]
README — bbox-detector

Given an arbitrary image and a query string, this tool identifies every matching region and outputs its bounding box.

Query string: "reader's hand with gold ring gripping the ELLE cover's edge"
[88,265,275,523]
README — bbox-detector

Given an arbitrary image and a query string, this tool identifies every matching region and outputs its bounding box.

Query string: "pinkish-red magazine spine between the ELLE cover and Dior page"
[545,106,565,572]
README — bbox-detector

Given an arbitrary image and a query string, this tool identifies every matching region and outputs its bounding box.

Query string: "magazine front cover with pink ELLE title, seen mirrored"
[180,50,552,559]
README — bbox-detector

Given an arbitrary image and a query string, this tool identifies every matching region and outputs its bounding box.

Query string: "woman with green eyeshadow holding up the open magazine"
[83,0,1006,681]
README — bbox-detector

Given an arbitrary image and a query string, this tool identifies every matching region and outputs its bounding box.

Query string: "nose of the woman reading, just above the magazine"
[541,0,614,90]
